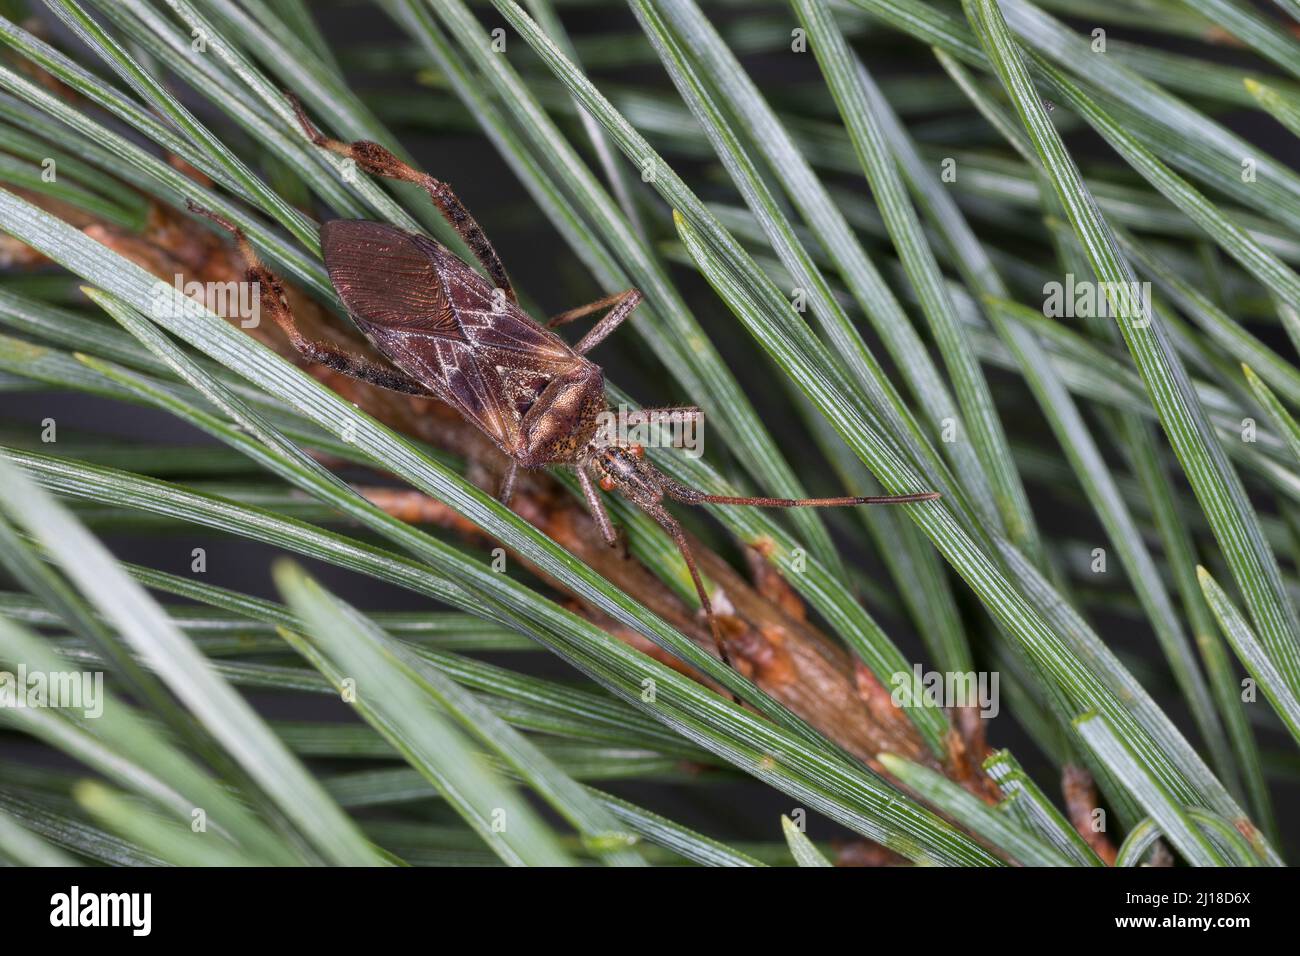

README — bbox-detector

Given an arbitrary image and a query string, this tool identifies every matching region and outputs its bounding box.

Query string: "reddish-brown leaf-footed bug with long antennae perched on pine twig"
[190,95,939,662]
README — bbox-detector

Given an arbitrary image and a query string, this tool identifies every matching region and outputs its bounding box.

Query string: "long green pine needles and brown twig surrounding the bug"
[0,0,1300,866]
